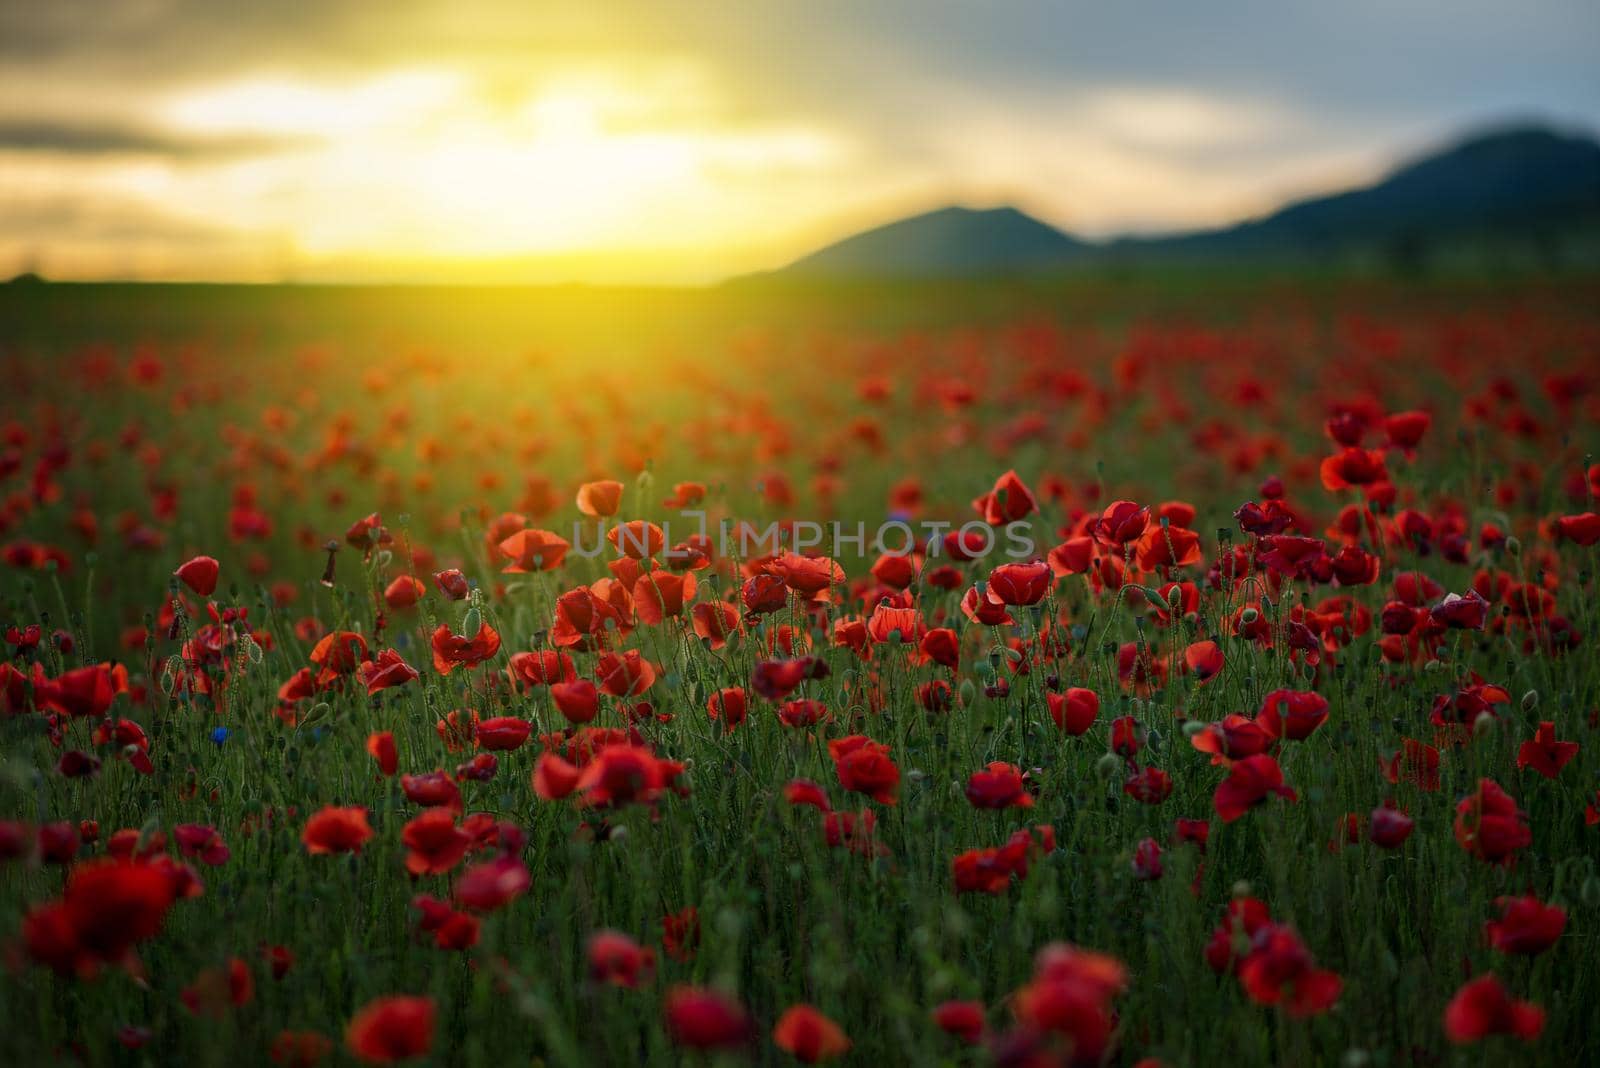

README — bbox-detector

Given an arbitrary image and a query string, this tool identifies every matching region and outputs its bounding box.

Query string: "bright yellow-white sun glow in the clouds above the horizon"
[9,67,848,281]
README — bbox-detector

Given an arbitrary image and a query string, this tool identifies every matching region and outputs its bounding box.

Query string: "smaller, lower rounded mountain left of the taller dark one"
[782,208,1091,278]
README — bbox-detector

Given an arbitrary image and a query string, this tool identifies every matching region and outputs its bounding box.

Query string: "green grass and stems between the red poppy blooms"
[0,280,1600,1065]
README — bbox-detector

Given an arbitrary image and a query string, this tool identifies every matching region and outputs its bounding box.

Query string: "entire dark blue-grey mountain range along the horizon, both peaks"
[779,125,1600,278]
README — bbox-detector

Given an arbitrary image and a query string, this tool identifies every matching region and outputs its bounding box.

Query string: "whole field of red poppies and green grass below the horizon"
[0,280,1600,1068]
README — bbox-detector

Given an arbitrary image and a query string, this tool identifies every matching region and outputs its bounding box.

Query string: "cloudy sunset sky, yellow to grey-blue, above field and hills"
[0,0,1600,283]
